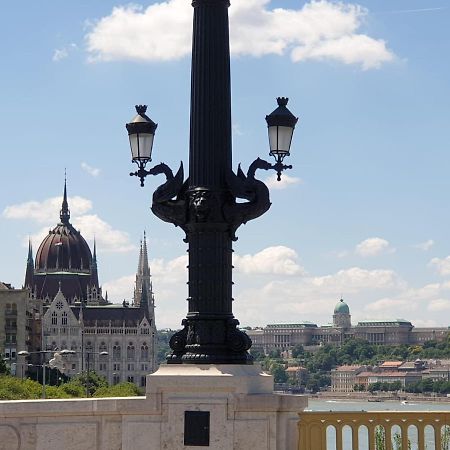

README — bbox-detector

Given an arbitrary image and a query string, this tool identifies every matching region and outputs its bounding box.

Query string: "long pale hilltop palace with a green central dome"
[246,299,449,354]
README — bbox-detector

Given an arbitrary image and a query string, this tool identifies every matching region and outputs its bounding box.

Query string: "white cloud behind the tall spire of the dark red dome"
[3,196,136,252]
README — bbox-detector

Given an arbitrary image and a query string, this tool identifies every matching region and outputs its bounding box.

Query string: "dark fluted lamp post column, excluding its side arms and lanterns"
[168,0,252,364]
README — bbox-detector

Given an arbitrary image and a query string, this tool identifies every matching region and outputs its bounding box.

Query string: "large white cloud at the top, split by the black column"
[86,0,394,70]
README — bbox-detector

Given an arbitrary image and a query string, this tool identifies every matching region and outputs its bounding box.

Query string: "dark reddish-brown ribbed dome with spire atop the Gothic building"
[25,182,107,305]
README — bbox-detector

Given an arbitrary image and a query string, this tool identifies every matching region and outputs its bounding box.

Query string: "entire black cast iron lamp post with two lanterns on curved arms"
[126,0,297,364]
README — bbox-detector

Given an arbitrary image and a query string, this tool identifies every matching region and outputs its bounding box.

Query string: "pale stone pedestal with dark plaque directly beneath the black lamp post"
[146,365,307,450]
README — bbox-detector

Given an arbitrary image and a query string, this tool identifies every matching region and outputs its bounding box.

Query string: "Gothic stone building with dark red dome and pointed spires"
[25,184,157,386]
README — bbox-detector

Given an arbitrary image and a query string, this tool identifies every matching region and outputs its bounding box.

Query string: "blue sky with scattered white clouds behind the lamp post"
[0,0,450,328]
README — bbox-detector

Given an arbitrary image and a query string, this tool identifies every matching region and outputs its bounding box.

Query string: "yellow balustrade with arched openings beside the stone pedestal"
[298,411,450,450]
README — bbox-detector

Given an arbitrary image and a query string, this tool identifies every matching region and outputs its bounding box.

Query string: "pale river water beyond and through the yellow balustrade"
[306,399,450,450]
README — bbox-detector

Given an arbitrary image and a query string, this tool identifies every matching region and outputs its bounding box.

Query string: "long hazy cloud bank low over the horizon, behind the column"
[103,246,450,328]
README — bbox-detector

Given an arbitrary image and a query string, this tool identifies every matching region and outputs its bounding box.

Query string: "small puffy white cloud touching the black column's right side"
[233,245,304,275]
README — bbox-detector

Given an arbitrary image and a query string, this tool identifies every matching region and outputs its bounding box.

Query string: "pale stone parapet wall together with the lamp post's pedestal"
[0,365,307,450]
